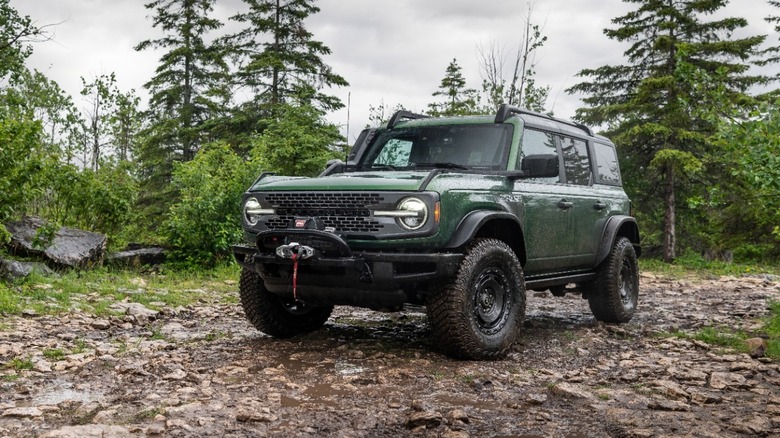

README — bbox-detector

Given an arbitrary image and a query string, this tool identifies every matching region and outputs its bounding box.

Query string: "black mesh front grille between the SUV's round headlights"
[265,192,384,233]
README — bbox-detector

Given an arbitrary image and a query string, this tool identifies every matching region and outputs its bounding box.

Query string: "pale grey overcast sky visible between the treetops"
[10,0,780,142]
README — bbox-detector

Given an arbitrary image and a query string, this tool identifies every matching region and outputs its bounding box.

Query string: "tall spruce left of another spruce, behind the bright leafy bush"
[135,0,229,219]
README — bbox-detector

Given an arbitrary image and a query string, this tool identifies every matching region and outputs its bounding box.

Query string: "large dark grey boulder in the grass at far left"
[6,216,106,268]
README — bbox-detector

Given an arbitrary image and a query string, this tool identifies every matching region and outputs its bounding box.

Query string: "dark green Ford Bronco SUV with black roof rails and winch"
[234,105,640,359]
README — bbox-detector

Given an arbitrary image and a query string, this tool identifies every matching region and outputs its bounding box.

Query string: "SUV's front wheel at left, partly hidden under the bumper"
[239,269,333,338]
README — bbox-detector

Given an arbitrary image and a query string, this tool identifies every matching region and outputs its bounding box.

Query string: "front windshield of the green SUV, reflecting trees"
[358,123,512,170]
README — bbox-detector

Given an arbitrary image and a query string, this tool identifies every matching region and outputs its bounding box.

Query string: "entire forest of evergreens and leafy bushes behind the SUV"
[0,0,780,266]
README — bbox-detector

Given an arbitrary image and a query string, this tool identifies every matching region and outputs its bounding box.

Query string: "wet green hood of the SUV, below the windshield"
[249,171,430,192]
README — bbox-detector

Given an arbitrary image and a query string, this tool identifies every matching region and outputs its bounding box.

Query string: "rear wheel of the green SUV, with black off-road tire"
[584,237,639,323]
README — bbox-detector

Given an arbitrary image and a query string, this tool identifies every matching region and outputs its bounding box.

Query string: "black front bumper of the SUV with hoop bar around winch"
[233,230,463,308]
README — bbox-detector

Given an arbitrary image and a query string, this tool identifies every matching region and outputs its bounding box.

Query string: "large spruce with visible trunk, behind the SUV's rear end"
[567,0,765,261]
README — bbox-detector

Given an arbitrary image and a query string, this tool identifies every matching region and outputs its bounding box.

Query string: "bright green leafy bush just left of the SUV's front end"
[162,143,255,266]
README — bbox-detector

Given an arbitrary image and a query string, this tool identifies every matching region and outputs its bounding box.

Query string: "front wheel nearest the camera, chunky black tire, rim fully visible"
[427,239,525,359]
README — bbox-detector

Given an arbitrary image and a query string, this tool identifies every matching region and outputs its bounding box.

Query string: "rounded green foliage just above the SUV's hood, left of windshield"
[252,105,344,176]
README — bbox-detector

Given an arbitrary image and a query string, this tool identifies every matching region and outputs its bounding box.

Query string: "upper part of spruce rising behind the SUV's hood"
[224,0,349,120]
